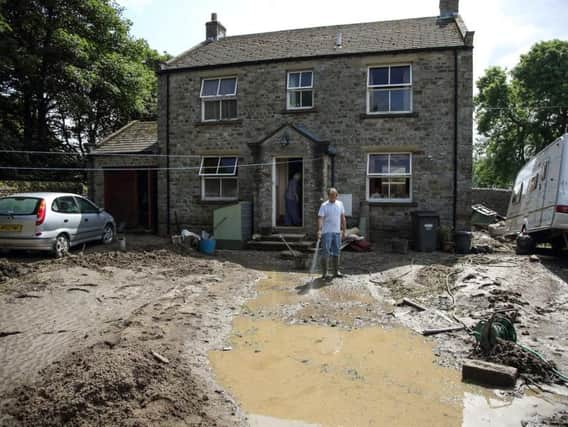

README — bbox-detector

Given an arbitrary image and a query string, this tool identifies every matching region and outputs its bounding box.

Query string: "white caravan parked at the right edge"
[507,133,568,250]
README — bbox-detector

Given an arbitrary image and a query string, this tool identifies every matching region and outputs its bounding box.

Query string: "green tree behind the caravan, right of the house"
[474,40,568,186]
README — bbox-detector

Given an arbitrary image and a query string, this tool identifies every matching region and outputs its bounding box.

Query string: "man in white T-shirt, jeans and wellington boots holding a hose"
[318,188,346,279]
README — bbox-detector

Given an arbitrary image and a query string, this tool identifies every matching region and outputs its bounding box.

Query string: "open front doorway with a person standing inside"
[273,157,304,227]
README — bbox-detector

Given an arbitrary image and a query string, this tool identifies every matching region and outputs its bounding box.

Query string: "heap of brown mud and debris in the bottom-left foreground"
[1,348,214,426]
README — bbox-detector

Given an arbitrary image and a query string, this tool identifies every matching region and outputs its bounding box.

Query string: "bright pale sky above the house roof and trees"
[117,0,568,86]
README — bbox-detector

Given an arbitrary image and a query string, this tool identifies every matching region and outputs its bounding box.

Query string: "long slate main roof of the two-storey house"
[165,16,466,70]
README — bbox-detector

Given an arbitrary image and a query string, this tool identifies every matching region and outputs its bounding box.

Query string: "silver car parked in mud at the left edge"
[0,193,116,258]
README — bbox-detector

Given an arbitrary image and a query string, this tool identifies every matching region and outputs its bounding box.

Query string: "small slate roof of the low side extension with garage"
[91,120,158,155]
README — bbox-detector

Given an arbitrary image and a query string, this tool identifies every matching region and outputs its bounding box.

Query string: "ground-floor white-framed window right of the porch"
[367,153,412,202]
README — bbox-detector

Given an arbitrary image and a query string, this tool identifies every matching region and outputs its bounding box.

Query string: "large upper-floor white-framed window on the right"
[367,65,412,114]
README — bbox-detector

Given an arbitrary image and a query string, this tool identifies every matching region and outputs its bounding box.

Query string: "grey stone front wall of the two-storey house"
[158,50,473,240]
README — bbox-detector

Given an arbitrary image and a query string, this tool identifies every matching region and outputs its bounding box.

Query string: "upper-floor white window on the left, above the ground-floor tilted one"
[201,77,237,122]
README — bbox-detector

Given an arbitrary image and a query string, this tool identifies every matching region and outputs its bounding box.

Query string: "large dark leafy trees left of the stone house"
[0,0,167,179]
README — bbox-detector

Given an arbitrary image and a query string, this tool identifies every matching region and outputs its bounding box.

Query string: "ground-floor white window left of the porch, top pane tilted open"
[199,157,239,200]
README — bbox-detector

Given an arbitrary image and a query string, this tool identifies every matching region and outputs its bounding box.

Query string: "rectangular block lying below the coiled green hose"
[462,359,519,388]
